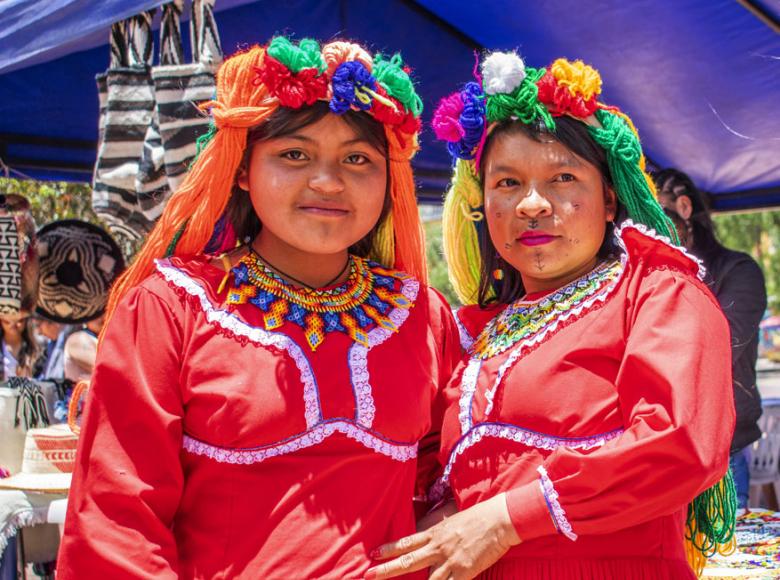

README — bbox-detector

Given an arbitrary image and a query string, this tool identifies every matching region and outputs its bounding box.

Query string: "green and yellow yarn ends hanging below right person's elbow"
[686,469,737,556]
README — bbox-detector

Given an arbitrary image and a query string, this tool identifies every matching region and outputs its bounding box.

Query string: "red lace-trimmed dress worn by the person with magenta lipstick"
[436,222,734,580]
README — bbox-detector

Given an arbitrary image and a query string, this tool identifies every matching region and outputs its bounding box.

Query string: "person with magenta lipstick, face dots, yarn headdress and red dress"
[369,53,735,580]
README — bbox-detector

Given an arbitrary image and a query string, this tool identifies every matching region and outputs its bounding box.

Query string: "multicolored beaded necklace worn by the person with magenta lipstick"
[471,260,623,360]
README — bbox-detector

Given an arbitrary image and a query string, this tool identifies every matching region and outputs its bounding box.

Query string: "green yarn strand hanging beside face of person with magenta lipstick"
[588,109,679,244]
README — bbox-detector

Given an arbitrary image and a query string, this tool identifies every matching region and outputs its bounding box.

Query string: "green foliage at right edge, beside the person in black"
[713,210,780,313]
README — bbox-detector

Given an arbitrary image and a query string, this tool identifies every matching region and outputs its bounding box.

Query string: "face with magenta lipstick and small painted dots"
[484,132,616,292]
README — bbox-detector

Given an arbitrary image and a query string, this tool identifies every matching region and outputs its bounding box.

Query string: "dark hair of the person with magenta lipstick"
[477,116,622,308]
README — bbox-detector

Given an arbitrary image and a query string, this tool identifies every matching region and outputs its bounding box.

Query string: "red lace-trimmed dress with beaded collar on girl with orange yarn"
[58,258,461,580]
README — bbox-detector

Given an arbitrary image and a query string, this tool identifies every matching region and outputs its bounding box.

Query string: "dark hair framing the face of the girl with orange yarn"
[225,101,391,258]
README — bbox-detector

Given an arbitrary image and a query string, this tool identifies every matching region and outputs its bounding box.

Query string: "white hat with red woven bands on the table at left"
[0,424,78,493]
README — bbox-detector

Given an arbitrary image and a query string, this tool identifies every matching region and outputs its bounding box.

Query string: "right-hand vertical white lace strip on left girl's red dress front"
[347,278,420,427]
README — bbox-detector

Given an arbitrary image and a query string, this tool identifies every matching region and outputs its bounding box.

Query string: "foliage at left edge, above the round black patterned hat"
[0,177,105,228]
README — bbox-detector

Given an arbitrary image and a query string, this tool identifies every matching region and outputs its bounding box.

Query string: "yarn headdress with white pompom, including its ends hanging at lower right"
[433,52,736,575]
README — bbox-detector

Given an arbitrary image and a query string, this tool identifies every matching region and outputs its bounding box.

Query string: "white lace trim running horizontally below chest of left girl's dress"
[182,419,418,465]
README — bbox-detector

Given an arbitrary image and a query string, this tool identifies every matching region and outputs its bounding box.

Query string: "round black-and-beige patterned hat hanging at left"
[36,219,125,324]
